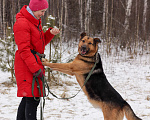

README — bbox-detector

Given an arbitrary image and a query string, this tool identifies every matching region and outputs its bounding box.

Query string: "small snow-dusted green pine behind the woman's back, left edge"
[0,27,16,82]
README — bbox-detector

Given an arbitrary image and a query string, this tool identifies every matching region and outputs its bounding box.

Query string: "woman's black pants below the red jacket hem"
[17,97,40,120]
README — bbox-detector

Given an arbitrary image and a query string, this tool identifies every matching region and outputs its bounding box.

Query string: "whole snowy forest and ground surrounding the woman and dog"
[0,0,150,120]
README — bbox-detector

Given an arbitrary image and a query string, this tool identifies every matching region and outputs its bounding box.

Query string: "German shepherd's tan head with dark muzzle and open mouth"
[78,33,101,57]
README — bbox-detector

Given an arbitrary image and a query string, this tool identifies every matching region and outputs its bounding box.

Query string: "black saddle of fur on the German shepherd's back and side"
[81,54,125,107]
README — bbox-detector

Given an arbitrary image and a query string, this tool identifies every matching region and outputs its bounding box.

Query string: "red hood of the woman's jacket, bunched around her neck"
[16,5,41,26]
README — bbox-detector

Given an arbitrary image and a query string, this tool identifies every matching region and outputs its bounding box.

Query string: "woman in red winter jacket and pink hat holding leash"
[13,0,59,120]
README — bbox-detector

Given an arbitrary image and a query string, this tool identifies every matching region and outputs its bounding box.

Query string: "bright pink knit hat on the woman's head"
[29,0,48,11]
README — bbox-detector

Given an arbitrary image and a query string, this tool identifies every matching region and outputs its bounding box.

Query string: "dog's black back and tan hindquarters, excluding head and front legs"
[85,54,141,120]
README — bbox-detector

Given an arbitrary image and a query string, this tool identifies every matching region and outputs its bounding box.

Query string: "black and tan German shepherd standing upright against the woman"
[42,33,141,120]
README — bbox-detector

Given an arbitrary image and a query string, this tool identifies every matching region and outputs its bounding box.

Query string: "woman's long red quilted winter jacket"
[13,5,54,97]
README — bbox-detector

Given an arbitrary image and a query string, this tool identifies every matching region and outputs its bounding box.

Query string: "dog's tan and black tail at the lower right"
[123,102,142,120]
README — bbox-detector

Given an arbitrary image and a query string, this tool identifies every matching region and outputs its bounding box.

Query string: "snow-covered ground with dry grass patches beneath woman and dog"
[0,43,150,120]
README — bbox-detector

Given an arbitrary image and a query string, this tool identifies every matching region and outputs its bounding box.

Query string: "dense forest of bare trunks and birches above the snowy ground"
[0,0,150,78]
